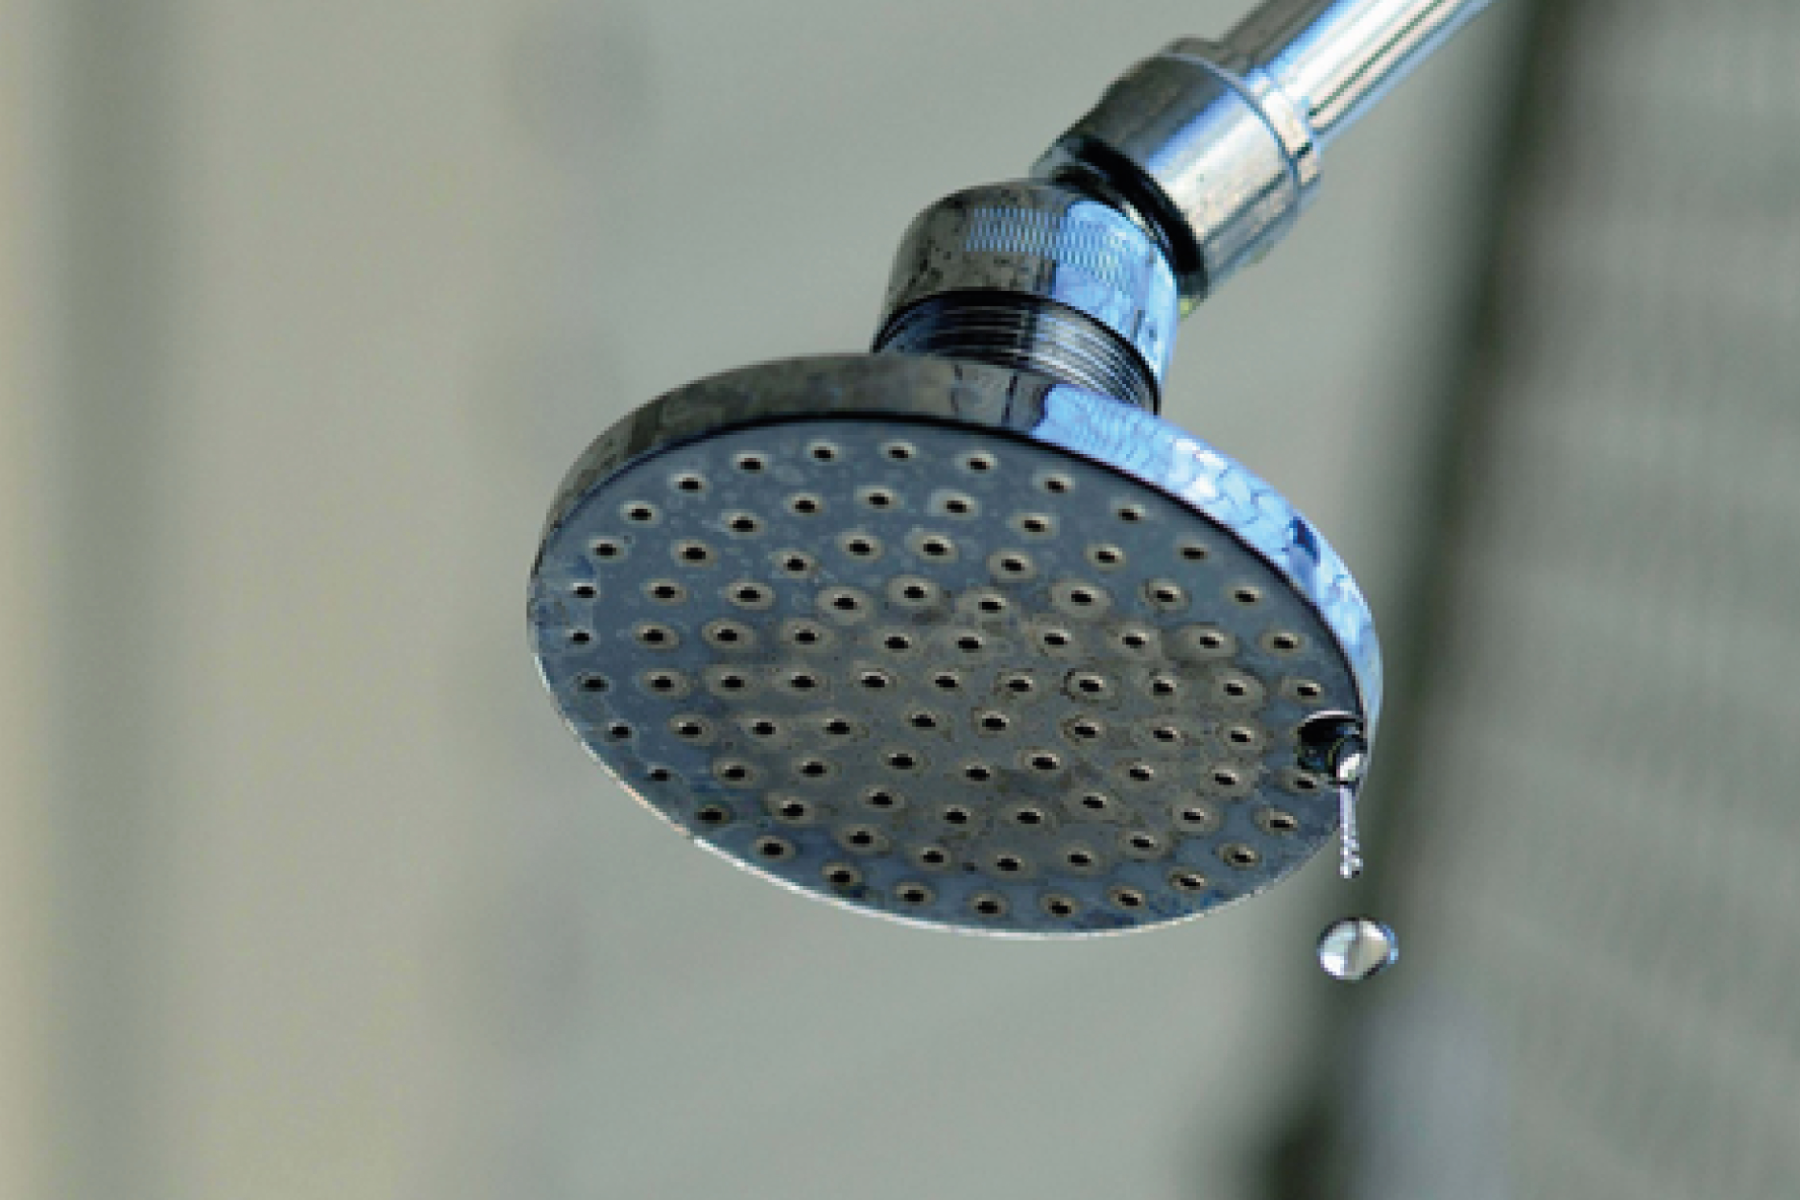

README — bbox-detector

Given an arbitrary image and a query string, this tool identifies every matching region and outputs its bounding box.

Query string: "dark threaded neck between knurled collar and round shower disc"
[875,291,1156,412]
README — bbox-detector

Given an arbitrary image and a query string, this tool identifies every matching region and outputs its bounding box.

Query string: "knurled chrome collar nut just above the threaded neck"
[878,180,1181,392]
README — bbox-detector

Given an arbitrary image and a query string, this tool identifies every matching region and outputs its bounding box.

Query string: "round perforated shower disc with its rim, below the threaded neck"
[531,358,1375,936]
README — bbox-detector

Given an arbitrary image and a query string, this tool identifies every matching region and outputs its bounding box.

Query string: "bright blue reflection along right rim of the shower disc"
[1030,387,1381,732]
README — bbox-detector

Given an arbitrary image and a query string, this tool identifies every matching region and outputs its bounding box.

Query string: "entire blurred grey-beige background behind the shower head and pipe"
[0,0,1800,1200]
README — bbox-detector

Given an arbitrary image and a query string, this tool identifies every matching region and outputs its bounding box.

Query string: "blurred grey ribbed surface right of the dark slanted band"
[1303,0,1800,1200]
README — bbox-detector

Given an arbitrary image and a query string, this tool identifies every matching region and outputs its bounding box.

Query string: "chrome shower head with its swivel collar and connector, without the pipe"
[529,5,1490,936]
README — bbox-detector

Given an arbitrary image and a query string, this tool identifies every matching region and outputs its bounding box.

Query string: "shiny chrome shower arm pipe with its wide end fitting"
[1033,0,1489,313]
